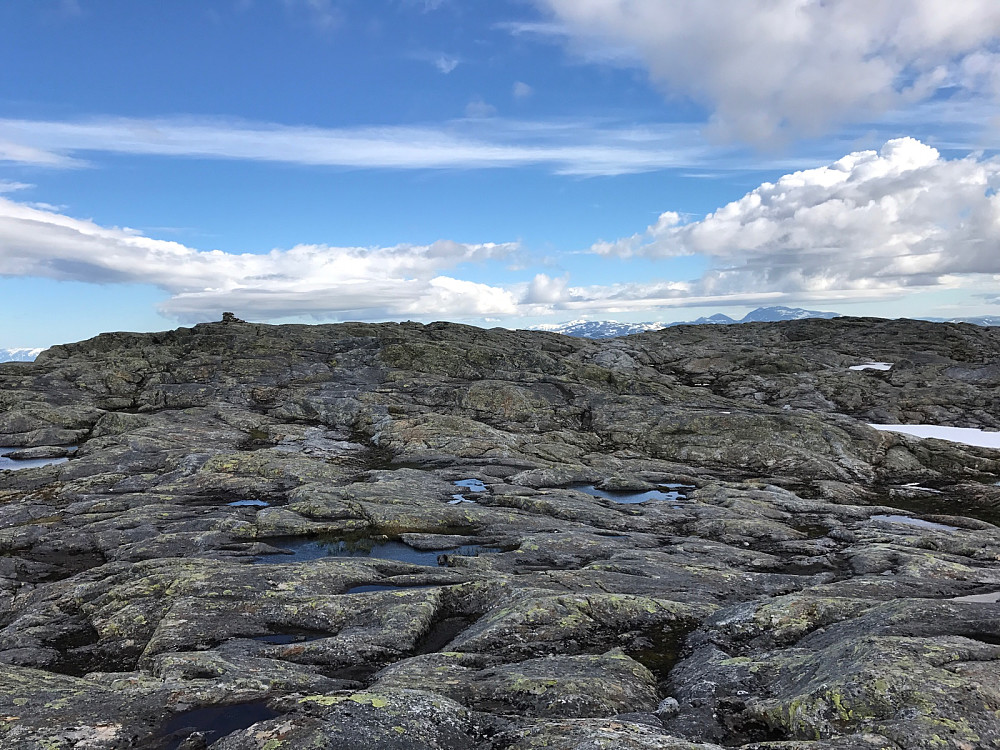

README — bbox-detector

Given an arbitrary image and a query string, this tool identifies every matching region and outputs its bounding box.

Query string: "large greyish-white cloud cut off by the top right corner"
[536,0,1000,143]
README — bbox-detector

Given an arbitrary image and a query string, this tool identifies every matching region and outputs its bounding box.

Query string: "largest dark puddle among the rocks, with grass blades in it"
[251,537,501,568]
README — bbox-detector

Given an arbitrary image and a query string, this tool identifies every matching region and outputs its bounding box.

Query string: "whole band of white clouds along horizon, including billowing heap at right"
[0,138,1000,321]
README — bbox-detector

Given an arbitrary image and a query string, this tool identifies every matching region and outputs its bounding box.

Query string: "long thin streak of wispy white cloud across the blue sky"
[0,115,740,175]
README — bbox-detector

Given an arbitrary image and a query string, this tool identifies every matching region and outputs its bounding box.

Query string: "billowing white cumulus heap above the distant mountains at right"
[592,138,1000,298]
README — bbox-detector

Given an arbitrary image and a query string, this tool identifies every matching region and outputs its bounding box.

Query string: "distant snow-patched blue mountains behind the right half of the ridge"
[533,305,1000,339]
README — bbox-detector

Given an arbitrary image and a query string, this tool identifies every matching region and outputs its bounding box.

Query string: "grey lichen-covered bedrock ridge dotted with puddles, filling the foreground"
[0,318,1000,750]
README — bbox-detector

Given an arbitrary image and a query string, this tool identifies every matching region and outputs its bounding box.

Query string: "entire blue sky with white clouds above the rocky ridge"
[0,0,1000,348]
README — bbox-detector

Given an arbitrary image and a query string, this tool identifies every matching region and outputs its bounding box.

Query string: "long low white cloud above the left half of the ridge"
[0,198,517,320]
